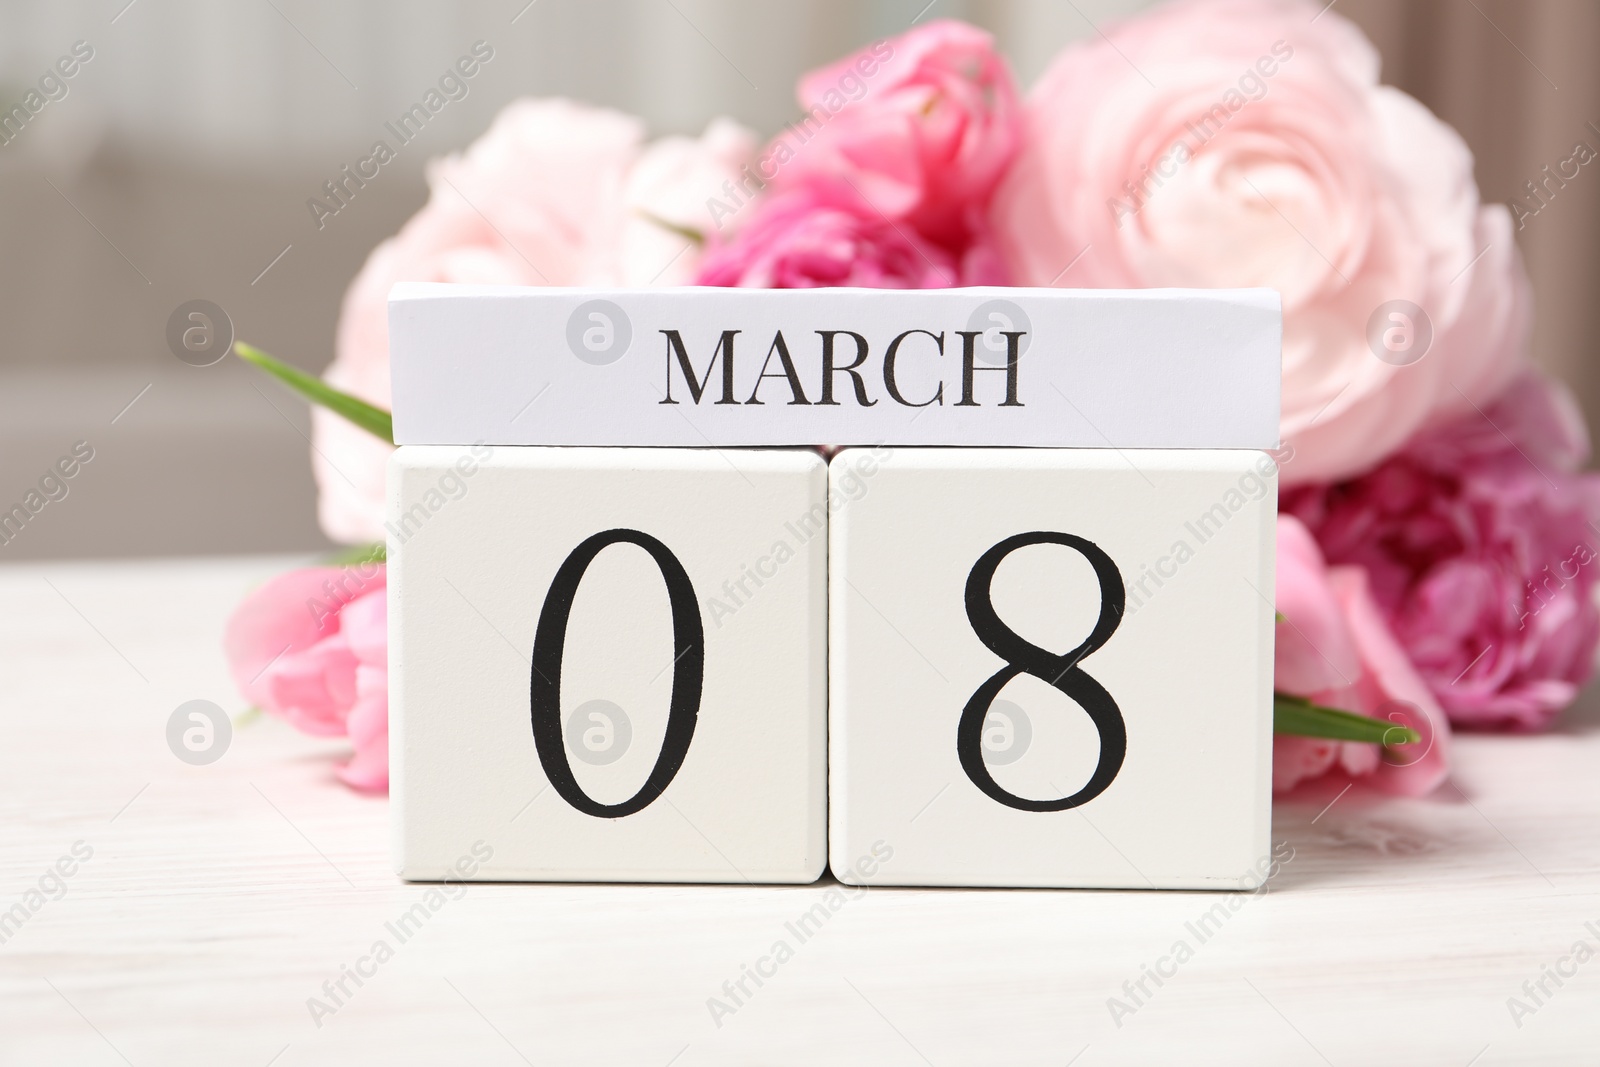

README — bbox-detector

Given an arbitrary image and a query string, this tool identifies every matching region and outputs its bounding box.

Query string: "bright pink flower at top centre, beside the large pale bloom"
[770,19,1022,254]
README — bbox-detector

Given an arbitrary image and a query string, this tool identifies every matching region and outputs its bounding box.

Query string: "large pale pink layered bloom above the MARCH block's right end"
[994,0,1530,483]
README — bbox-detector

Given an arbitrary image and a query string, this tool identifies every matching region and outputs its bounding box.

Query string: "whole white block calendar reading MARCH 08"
[389,285,1280,889]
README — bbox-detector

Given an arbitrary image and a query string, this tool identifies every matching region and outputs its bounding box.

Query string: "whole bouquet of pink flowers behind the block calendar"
[226,0,1600,793]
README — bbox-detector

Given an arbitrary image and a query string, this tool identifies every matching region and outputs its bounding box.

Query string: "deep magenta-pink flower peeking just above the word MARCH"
[698,192,958,290]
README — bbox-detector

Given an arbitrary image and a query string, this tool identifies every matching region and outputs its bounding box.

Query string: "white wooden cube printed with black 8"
[829,448,1277,889]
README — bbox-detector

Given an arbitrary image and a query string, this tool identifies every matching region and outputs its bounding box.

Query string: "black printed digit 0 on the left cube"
[528,530,706,819]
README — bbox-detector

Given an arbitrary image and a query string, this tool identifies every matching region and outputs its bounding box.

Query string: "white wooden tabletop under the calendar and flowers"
[0,558,1600,1067]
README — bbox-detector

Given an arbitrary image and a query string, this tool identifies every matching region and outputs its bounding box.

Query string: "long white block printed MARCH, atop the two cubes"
[389,283,1283,448]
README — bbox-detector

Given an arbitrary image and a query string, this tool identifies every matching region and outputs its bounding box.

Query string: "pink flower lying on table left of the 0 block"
[222,563,389,792]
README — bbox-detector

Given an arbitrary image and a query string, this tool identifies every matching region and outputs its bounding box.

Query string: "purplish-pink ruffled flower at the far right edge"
[1283,374,1600,729]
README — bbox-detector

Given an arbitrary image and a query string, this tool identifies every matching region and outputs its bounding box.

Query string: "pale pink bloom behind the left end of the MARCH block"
[312,99,755,544]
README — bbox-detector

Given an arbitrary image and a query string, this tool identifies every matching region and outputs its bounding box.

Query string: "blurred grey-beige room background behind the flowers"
[0,0,1600,560]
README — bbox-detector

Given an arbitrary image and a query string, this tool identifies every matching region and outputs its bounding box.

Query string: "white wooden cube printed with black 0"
[389,445,827,881]
